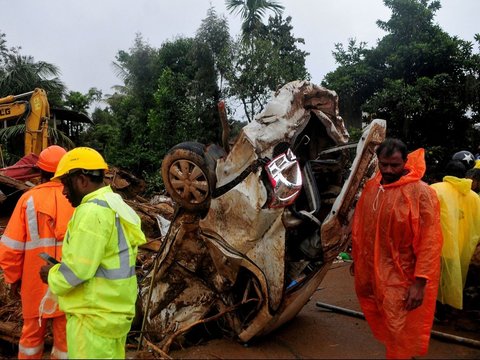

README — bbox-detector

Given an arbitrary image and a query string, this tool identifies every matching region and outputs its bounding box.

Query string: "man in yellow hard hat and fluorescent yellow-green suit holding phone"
[40,147,145,359]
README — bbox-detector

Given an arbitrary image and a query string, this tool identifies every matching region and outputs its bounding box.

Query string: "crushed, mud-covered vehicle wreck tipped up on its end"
[138,81,386,352]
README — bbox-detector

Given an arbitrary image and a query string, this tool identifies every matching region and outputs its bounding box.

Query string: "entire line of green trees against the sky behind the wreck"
[0,0,480,188]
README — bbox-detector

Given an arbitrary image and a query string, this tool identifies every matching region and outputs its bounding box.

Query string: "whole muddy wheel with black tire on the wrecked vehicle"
[162,142,215,211]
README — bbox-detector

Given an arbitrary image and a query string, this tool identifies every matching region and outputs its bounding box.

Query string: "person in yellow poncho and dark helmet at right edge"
[431,160,480,309]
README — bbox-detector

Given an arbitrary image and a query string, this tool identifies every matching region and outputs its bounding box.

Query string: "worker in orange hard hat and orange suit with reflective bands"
[0,145,73,359]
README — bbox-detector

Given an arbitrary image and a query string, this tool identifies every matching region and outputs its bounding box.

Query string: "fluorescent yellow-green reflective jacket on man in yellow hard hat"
[48,186,146,338]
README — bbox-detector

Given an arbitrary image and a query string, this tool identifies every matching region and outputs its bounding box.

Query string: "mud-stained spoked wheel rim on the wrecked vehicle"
[168,159,208,204]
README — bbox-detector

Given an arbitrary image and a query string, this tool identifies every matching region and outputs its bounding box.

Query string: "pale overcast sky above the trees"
[0,0,480,94]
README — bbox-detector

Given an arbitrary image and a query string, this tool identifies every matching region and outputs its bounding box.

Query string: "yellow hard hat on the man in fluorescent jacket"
[52,147,108,180]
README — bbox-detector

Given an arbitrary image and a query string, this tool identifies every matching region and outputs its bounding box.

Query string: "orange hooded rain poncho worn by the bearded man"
[352,149,442,358]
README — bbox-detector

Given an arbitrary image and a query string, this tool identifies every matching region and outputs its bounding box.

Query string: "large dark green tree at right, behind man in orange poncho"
[323,0,480,161]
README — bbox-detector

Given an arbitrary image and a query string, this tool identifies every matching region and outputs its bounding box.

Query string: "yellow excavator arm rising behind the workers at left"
[0,88,50,155]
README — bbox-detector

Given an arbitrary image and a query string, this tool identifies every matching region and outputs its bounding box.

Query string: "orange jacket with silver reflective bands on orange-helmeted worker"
[0,181,73,319]
